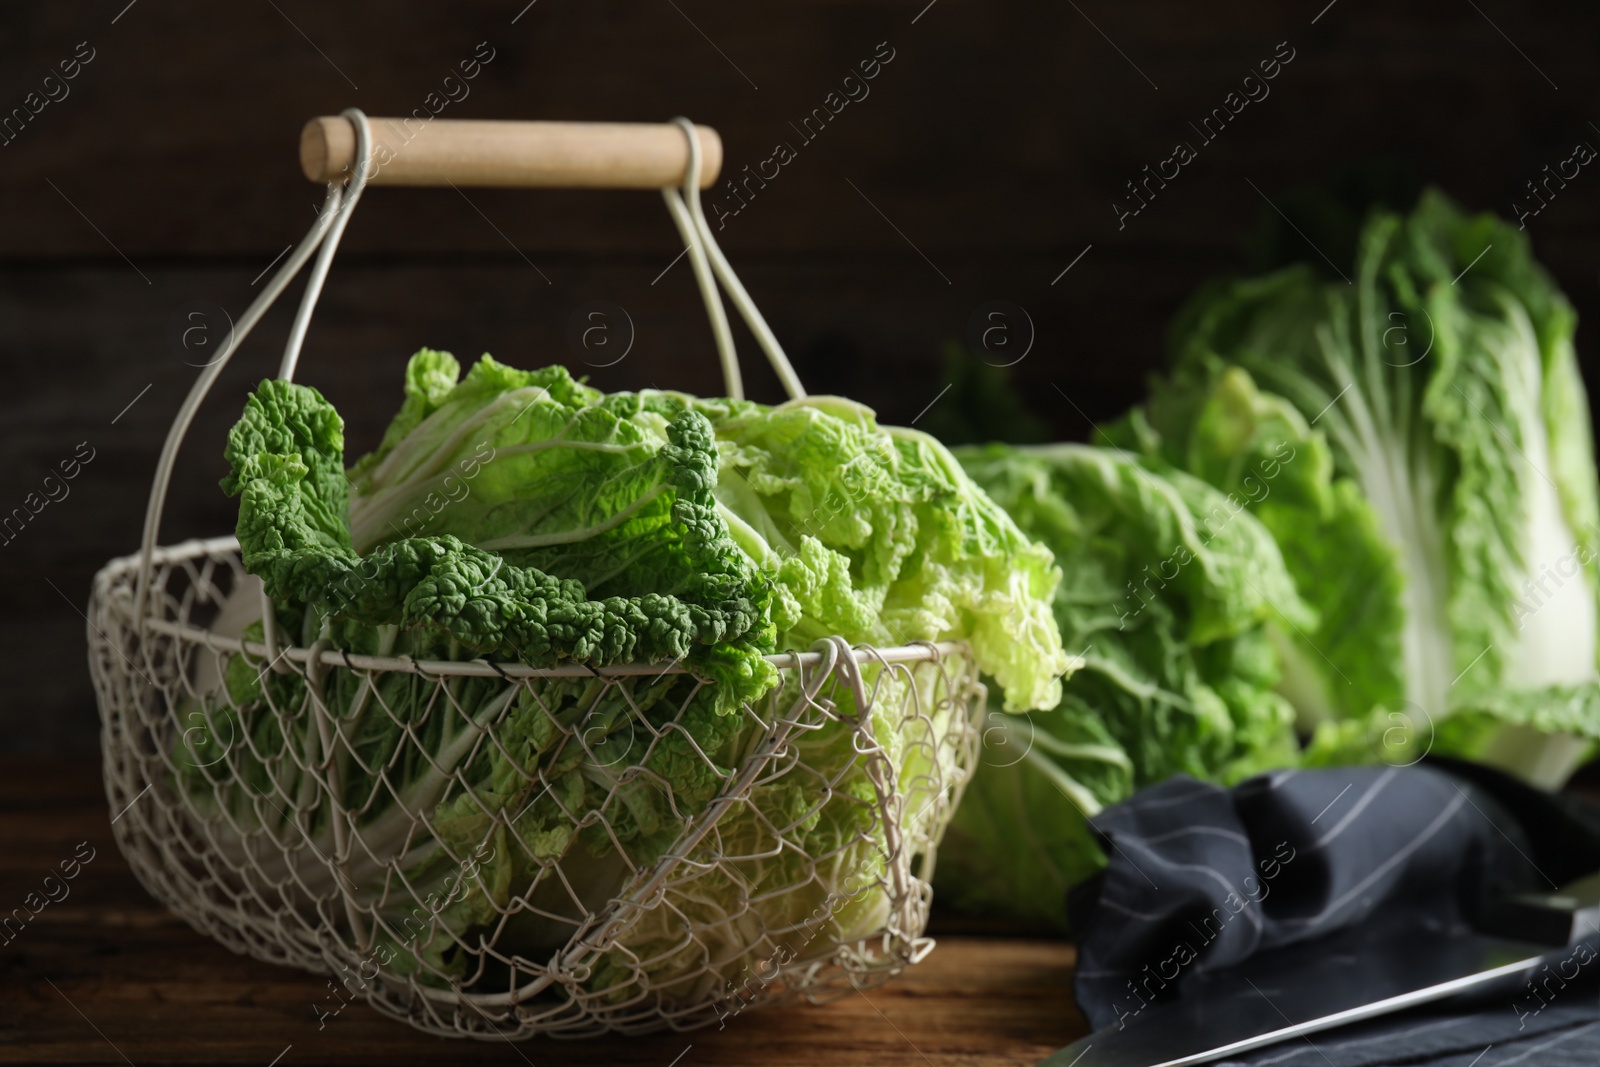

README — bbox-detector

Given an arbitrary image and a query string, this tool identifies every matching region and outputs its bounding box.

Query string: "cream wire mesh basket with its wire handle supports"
[88,112,984,1040]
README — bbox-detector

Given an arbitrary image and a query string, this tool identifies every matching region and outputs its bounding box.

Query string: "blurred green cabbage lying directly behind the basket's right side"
[936,445,1315,928]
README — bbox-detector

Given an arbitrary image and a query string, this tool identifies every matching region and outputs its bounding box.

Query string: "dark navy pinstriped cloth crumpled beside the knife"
[1069,761,1600,1067]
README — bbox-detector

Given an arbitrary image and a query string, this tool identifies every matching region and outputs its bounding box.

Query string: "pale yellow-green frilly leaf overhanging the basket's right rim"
[642,394,1072,710]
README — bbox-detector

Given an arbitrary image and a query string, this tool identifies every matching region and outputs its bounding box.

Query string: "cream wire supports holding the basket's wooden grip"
[133,107,806,627]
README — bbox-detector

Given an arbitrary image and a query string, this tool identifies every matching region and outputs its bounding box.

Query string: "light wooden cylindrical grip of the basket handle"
[301,115,722,189]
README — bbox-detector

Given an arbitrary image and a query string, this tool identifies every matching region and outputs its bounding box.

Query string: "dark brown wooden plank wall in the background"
[0,0,1600,752]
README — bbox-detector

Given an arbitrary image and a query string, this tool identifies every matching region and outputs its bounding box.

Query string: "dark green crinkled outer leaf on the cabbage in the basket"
[232,354,773,697]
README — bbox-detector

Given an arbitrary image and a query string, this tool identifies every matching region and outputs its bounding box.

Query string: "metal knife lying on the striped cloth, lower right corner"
[1038,873,1600,1067]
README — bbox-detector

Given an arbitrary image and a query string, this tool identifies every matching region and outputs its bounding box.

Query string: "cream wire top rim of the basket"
[93,534,971,678]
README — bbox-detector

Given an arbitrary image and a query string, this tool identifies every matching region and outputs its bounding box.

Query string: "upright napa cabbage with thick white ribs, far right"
[1110,192,1600,784]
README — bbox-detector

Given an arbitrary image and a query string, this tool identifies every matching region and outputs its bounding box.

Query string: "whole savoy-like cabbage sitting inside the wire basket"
[181,350,1072,1001]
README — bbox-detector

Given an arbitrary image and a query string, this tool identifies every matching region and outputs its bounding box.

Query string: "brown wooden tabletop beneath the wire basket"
[0,758,1085,1067]
